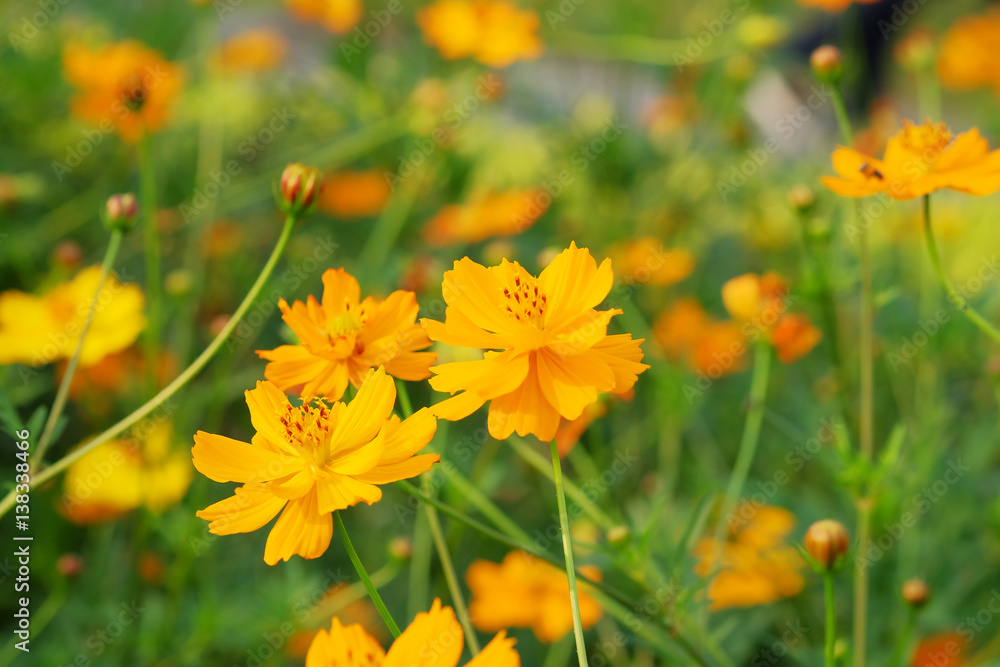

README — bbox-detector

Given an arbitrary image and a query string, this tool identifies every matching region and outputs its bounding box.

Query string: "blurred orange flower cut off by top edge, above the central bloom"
[417,0,542,67]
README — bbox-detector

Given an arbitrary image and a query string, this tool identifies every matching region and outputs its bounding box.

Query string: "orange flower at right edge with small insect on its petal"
[820,120,1000,200]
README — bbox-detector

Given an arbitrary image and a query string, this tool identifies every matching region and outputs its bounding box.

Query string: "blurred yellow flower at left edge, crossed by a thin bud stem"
[0,266,146,368]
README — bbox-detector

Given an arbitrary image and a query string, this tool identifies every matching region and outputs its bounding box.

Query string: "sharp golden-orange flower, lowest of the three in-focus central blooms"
[191,368,440,565]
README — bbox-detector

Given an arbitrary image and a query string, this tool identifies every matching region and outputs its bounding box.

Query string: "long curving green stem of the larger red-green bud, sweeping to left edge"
[0,216,297,516]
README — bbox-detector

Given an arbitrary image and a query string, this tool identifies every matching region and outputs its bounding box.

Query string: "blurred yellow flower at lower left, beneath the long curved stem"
[58,422,191,524]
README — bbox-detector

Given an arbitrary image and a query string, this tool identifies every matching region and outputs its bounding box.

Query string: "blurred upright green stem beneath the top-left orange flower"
[139,130,163,393]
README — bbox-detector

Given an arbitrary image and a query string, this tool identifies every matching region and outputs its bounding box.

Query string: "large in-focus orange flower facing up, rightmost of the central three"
[422,243,649,441]
